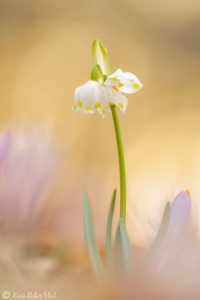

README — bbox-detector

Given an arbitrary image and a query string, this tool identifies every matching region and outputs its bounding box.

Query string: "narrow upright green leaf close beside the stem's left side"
[106,189,117,267]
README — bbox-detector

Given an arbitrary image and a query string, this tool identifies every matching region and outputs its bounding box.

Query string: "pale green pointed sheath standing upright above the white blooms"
[92,39,111,75]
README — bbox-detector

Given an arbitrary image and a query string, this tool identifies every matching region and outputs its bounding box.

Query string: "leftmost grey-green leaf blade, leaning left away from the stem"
[82,192,104,279]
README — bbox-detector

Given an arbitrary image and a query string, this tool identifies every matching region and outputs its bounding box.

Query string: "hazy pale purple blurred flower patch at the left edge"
[0,131,56,234]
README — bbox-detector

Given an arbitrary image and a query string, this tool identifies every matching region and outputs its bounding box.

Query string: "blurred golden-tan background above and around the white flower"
[0,0,200,248]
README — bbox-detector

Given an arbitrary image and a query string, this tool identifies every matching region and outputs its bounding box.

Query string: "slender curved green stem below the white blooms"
[110,105,126,224]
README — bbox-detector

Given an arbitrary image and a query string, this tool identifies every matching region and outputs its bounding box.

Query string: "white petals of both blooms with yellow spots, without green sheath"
[74,69,143,116]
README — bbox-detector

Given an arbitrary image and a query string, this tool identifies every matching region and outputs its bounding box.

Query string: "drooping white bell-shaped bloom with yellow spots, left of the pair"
[74,80,108,113]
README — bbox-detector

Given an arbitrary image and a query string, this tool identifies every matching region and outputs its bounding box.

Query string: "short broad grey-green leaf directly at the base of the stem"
[115,219,133,270]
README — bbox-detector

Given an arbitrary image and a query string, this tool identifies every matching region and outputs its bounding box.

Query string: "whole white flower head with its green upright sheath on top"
[73,40,143,116]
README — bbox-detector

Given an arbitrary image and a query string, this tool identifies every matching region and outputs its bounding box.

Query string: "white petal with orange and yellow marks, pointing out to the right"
[105,69,143,94]
